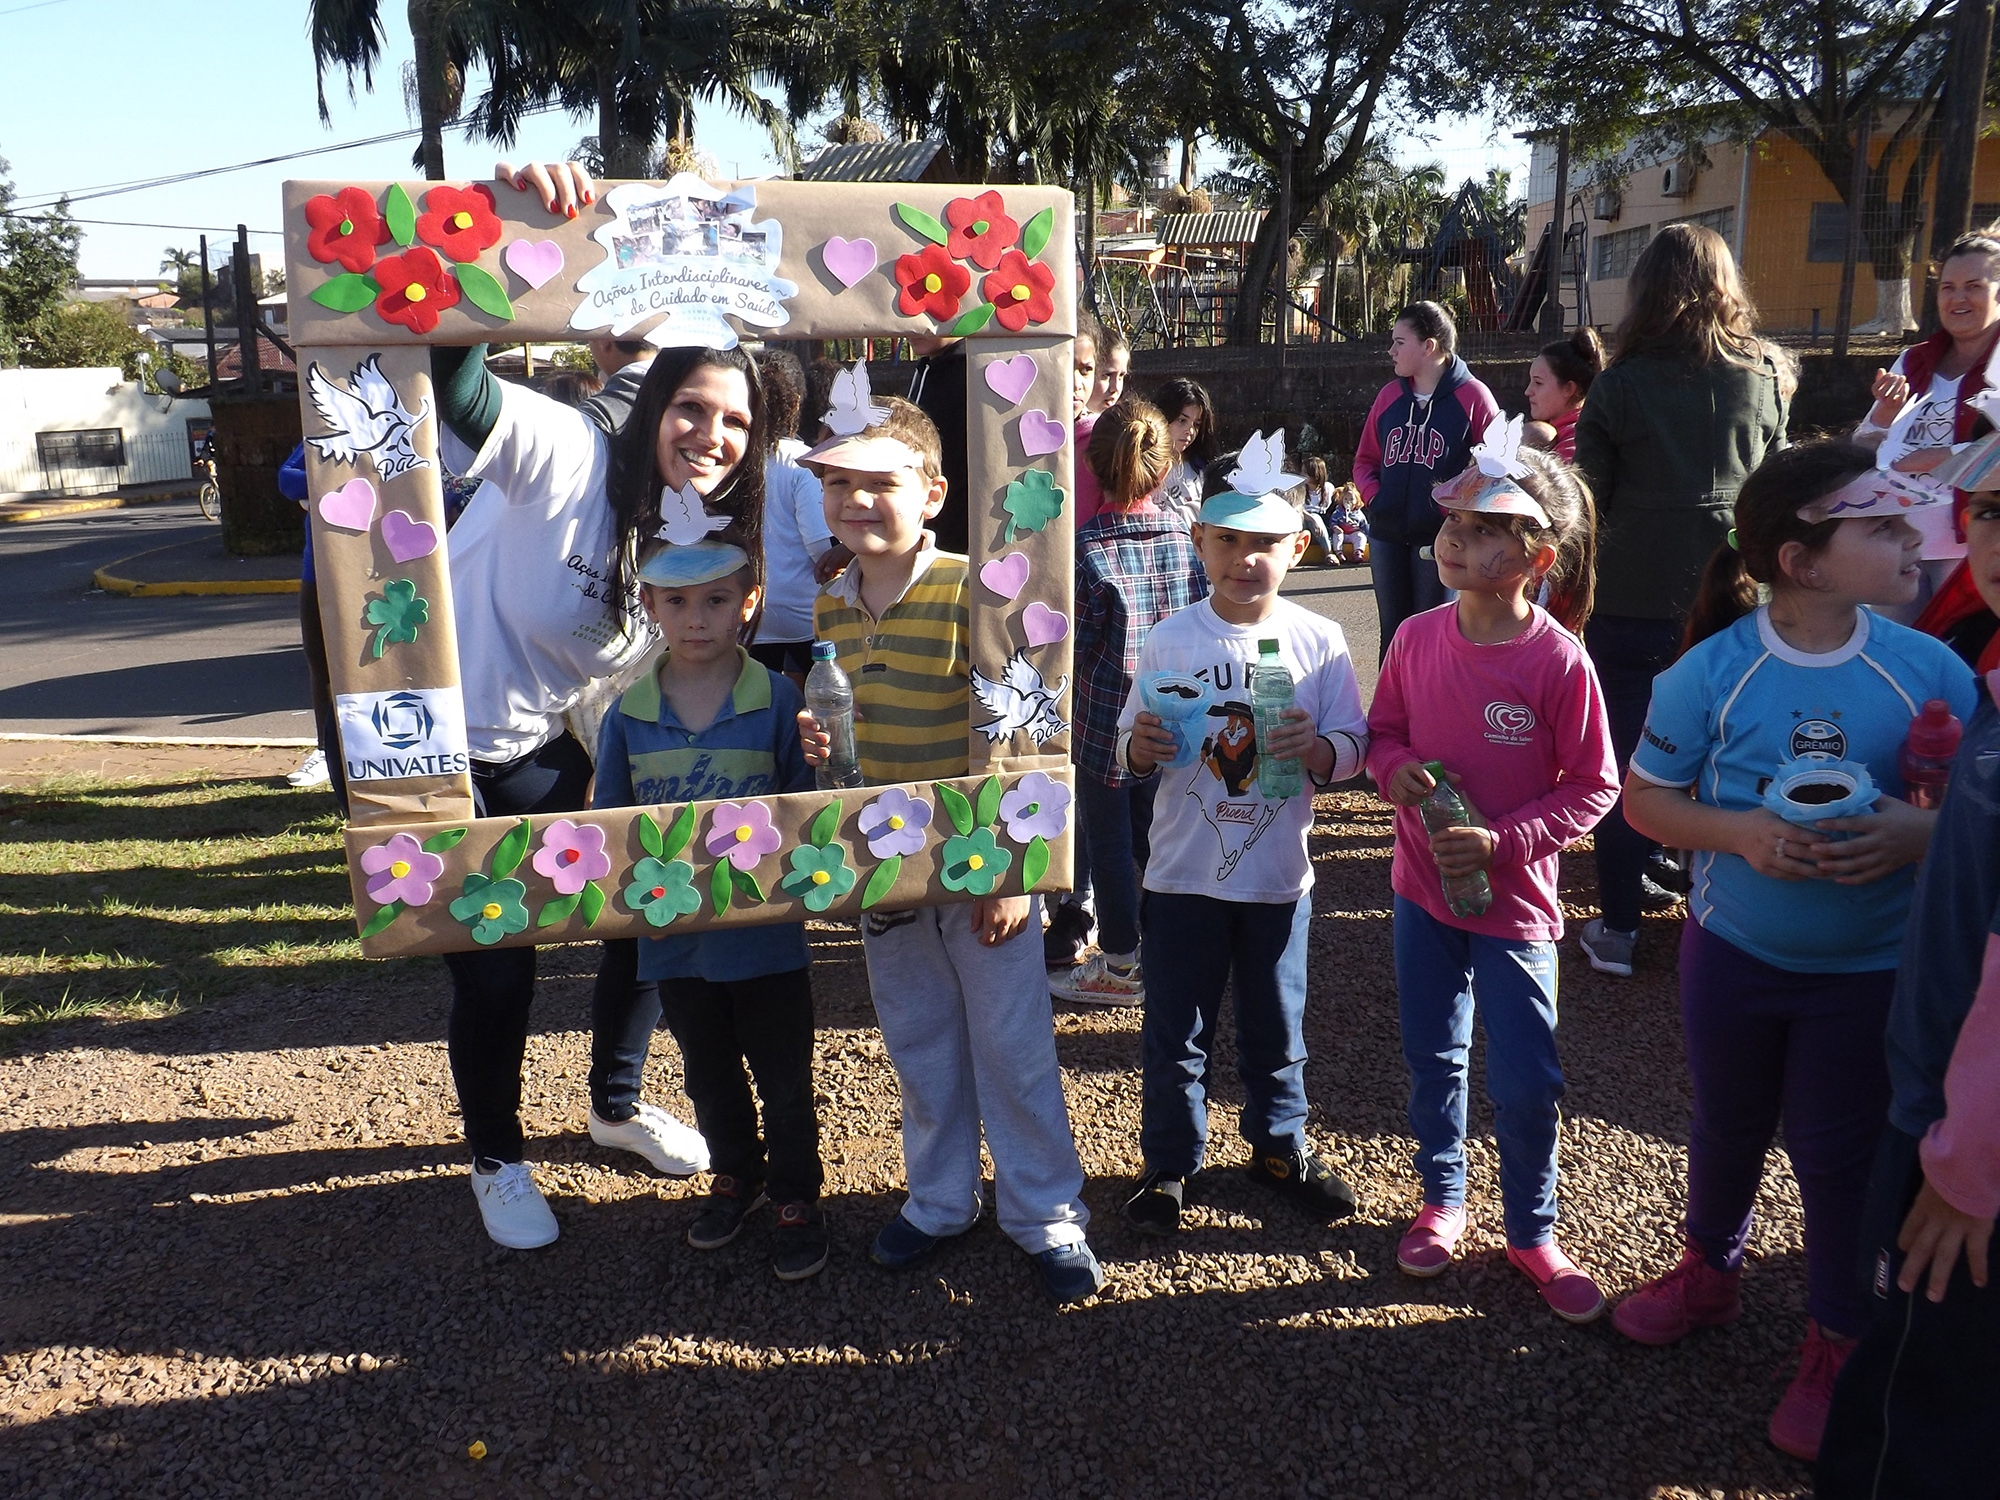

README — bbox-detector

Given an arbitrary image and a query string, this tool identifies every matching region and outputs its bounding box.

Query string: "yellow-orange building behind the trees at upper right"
[1528,128,2000,334]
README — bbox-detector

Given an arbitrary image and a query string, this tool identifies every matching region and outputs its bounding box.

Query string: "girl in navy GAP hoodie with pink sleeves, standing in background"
[1354,302,1500,656]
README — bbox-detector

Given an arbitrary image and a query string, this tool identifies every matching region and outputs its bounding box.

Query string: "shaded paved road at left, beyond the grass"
[0,500,312,738]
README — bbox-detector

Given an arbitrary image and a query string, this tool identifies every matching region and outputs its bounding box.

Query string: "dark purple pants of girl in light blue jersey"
[1680,920,1896,1338]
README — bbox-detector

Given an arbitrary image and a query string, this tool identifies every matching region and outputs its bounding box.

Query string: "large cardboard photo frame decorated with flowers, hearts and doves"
[284,176,1076,956]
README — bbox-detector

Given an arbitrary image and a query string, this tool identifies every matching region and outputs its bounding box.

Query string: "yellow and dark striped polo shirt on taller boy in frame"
[812,544,972,786]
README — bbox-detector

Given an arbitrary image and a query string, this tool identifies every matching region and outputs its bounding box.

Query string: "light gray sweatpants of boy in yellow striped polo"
[862,900,1090,1254]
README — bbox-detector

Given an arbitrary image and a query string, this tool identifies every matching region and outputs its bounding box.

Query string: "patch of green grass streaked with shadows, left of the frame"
[0,776,362,1038]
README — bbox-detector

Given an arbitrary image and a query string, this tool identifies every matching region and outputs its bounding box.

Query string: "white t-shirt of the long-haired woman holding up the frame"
[442,382,658,764]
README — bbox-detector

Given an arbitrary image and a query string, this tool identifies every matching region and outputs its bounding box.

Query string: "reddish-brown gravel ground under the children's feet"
[0,776,1808,1498]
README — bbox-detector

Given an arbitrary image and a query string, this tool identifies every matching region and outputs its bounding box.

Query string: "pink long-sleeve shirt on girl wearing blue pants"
[1368,604,1618,942]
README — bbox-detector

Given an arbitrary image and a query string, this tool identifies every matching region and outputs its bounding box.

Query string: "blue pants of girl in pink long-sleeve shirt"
[1396,896,1564,1250]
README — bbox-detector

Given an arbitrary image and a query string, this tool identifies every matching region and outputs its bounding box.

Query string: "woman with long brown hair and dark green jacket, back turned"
[1576,224,1790,974]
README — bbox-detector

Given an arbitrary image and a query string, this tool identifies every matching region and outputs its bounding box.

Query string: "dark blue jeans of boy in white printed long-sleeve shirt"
[1138,890,1312,1178]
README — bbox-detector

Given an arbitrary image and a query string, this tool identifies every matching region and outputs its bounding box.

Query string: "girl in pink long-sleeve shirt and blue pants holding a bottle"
[1368,418,1618,1322]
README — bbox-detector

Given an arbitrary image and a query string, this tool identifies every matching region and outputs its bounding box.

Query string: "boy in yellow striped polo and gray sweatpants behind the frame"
[798,398,1104,1302]
